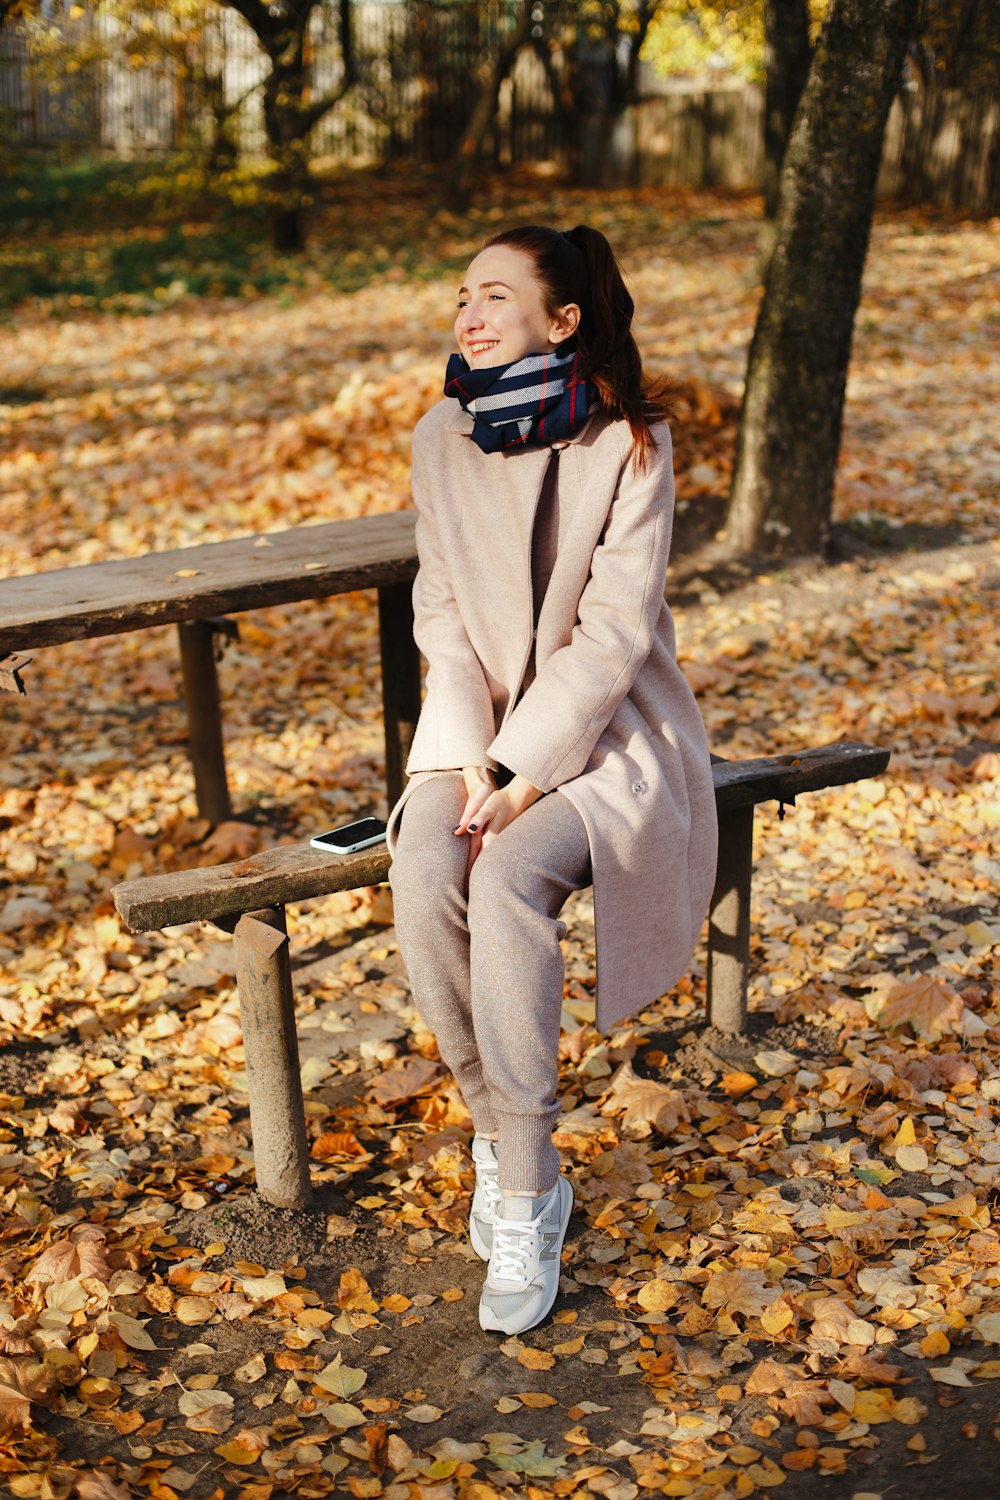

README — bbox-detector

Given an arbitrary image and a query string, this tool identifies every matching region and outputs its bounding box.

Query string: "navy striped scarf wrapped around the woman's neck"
[444,350,601,453]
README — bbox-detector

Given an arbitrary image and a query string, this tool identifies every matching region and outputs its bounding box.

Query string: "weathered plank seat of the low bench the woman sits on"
[112,744,889,932]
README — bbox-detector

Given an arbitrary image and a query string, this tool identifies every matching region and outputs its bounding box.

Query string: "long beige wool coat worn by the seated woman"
[387,399,718,1029]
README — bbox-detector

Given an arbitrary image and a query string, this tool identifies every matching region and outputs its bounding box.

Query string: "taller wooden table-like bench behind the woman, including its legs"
[0,510,420,824]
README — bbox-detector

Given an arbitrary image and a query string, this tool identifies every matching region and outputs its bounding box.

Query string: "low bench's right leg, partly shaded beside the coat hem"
[708,807,754,1032]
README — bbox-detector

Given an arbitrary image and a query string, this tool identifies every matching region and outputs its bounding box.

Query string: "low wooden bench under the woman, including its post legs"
[112,743,889,1208]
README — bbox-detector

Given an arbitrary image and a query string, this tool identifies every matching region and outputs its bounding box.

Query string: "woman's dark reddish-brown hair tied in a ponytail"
[487,224,670,468]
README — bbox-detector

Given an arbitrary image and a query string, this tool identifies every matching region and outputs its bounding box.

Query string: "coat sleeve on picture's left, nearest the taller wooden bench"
[406,431,496,776]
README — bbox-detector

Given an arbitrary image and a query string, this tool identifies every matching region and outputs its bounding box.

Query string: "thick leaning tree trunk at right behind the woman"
[726,0,918,555]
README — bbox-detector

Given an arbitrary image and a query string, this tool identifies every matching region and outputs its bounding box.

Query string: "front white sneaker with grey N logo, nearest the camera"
[480,1178,573,1334]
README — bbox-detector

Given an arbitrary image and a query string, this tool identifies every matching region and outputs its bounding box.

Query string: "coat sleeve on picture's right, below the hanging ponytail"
[489,425,673,792]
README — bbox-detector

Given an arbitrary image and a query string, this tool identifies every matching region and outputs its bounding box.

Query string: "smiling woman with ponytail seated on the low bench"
[388,225,717,1334]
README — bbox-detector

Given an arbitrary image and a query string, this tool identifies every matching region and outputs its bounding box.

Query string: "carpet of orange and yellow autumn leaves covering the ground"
[0,185,1000,1500]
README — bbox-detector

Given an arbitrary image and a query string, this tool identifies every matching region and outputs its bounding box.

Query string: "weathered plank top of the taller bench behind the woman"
[0,510,417,656]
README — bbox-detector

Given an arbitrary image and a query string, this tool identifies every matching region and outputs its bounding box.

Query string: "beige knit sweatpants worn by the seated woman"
[390,771,592,1193]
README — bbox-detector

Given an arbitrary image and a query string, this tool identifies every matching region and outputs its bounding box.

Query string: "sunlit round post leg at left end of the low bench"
[232,906,312,1209]
